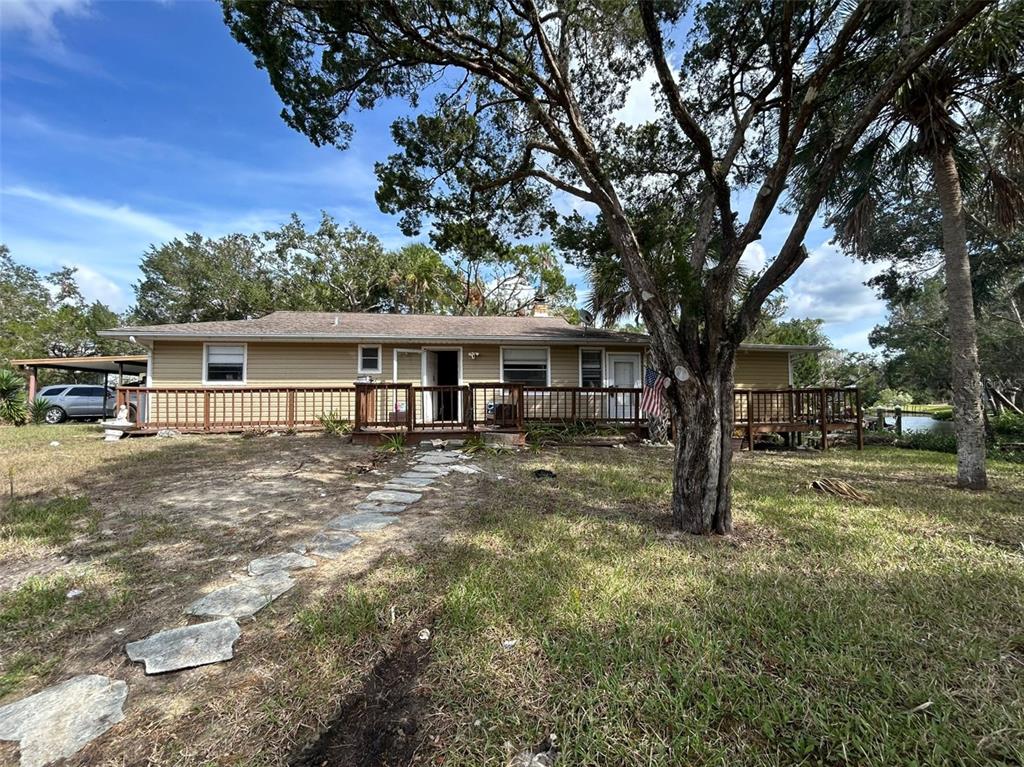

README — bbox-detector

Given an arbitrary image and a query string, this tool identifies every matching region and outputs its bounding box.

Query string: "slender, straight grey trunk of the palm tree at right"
[932,143,988,489]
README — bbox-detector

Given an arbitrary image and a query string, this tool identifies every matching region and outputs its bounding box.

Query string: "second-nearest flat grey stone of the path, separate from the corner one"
[125,617,242,674]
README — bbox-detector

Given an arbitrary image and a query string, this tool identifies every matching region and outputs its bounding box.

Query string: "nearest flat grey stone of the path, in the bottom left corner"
[0,674,128,767]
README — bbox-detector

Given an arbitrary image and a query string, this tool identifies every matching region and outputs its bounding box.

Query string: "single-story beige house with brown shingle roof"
[101,307,847,436]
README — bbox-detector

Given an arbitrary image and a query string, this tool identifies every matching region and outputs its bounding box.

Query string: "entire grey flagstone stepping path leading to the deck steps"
[0,449,482,767]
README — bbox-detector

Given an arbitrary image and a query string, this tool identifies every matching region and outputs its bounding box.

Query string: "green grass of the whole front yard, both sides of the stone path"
[0,427,1024,767]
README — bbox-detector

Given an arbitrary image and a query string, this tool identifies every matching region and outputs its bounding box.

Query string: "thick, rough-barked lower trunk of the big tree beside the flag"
[672,359,733,535]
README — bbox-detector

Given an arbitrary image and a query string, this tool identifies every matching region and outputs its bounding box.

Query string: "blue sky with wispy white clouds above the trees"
[0,0,884,350]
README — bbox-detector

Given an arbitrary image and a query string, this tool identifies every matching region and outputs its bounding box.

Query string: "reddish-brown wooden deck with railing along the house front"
[118,383,863,449]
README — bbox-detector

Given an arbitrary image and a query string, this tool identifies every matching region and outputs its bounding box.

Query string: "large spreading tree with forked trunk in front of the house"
[224,0,988,532]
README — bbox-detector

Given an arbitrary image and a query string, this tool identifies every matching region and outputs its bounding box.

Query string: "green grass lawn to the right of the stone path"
[294,449,1024,766]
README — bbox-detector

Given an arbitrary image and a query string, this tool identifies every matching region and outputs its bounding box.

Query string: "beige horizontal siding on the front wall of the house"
[152,341,790,388]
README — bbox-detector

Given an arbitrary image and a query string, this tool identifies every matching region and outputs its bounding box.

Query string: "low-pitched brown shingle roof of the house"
[100,311,648,344]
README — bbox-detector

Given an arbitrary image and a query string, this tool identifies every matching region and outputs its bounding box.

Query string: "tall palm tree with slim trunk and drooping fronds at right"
[833,0,1024,489]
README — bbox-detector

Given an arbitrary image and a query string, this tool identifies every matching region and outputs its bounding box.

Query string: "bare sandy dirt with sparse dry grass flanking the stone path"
[0,434,487,765]
